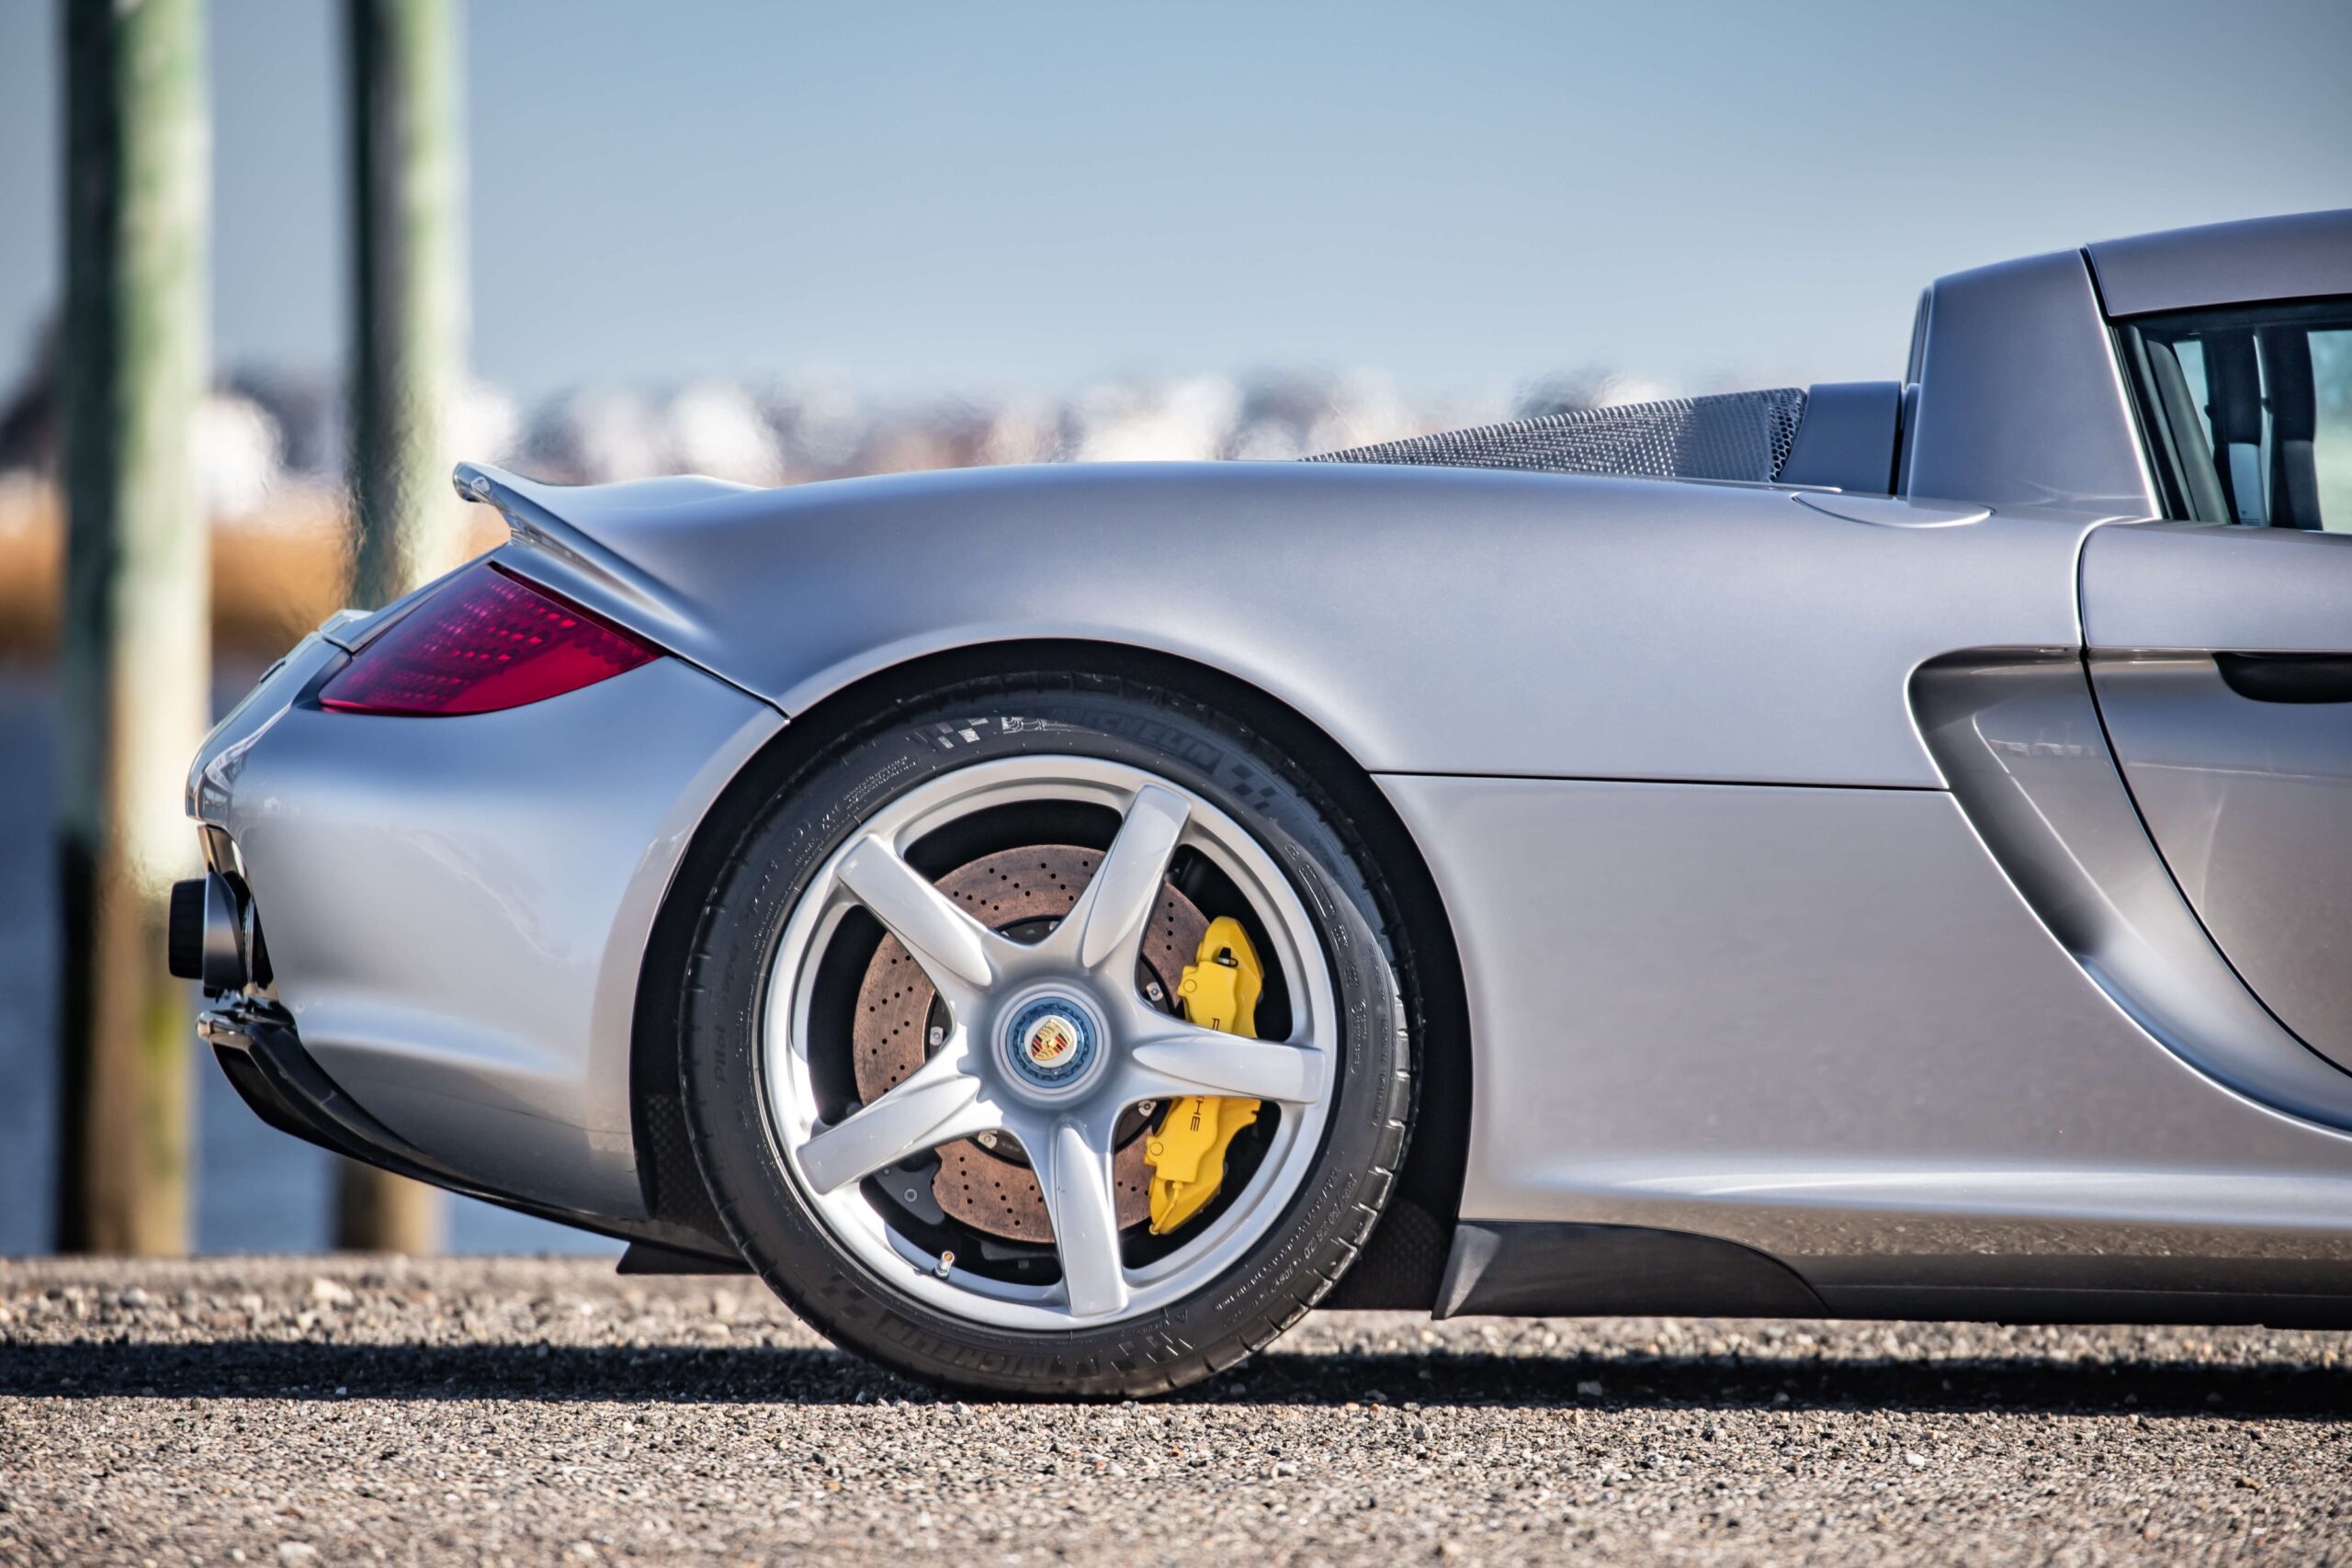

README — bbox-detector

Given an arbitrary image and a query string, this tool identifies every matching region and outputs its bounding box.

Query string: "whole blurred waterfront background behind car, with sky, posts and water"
[0,0,2352,1253]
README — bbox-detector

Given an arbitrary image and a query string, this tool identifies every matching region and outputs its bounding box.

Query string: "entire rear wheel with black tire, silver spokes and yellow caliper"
[677,677,1411,1394]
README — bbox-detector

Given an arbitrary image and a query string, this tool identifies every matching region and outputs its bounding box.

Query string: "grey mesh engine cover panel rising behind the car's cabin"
[1306,386,1804,482]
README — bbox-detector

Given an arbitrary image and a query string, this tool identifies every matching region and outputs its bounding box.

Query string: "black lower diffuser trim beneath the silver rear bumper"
[195,1001,739,1267]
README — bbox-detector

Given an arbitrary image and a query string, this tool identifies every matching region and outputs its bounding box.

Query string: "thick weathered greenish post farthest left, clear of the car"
[56,0,211,1253]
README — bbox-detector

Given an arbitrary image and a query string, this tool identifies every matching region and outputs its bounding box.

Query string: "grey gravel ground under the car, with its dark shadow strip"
[0,1258,2352,1568]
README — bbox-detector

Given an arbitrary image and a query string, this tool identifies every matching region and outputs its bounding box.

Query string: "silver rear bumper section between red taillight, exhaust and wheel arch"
[188,602,783,1236]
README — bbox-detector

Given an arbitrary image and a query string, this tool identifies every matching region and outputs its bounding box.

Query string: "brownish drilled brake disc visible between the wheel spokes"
[852,844,1209,1244]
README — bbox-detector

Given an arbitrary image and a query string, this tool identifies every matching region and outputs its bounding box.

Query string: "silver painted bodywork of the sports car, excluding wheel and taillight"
[195,214,2352,1316]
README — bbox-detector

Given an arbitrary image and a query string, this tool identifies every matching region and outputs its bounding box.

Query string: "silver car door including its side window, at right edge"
[2082,301,2352,1069]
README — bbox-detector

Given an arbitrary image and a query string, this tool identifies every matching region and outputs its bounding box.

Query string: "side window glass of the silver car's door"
[2124,301,2352,534]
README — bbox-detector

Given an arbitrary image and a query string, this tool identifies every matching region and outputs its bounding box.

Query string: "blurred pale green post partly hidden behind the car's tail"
[336,0,466,1253]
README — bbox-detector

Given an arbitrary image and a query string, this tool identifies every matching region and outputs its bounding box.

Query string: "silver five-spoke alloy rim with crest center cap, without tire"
[760,755,1339,1328]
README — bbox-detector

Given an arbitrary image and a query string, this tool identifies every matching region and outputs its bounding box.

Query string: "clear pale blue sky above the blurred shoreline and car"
[0,0,2352,398]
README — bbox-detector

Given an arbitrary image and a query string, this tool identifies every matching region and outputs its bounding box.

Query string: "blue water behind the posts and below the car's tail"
[0,665,621,1256]
